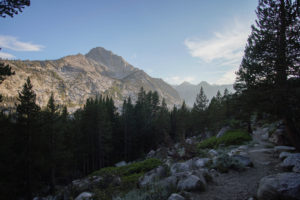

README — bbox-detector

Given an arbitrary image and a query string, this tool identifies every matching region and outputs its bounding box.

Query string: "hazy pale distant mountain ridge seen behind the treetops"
[173,81,234,107]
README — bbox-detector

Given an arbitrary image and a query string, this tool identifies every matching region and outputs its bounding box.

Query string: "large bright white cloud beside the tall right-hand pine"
[184,19,251,84]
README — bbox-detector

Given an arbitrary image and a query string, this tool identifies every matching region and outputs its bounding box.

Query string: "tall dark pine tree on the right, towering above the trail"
[235,0,300,149]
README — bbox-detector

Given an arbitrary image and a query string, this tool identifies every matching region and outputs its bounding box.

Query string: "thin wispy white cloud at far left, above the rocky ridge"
[0,35,43,51]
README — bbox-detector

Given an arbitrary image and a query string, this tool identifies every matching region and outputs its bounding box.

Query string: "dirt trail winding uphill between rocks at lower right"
[191,130,282,200]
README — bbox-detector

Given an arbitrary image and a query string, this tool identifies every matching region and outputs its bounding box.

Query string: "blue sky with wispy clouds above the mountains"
[0,0,258,84]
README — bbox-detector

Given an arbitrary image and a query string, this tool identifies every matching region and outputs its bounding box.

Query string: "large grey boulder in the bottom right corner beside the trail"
[257,173,300,200]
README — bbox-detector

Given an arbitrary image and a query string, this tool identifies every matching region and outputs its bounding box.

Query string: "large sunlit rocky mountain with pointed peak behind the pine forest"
[0,47,181,111]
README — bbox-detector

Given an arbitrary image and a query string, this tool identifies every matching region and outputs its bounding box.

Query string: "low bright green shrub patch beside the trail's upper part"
[198,130,251,149]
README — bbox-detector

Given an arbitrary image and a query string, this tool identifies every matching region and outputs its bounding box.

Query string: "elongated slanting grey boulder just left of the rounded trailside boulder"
[139,166,167,187]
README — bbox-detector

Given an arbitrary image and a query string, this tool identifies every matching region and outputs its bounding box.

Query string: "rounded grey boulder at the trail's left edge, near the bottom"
[177,175,206,191]
